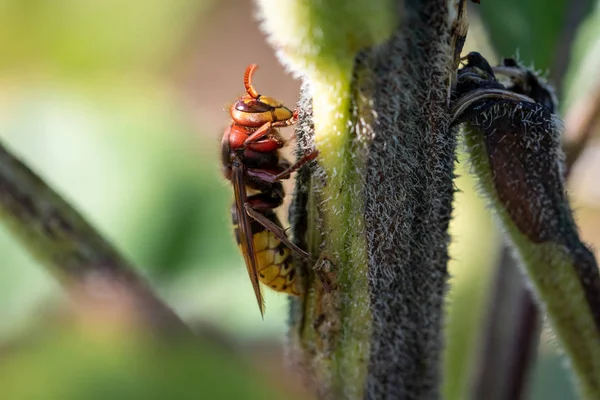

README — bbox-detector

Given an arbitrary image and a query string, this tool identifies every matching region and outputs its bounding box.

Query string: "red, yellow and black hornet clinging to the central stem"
[221,64,318,315]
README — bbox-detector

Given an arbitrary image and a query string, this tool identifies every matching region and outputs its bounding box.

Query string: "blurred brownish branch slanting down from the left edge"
[0,144,191,335]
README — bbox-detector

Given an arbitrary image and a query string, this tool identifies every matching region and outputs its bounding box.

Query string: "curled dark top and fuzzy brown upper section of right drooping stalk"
[454,52,575,243]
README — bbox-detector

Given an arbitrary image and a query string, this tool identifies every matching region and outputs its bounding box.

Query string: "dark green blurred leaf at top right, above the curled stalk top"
[477,0,592,70]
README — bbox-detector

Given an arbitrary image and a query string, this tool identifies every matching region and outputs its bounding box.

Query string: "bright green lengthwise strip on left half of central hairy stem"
[309,65,370,393]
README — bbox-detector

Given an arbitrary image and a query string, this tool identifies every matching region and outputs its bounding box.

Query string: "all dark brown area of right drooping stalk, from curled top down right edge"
[453,53,600,331]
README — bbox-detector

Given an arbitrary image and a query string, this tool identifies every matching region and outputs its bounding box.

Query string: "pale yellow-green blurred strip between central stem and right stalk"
[443,158,498,400]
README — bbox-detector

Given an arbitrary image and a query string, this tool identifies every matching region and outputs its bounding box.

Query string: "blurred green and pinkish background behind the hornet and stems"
[0,0,600,399]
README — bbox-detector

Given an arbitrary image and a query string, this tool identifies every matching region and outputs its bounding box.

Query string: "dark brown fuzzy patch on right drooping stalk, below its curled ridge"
[466,100,573,243]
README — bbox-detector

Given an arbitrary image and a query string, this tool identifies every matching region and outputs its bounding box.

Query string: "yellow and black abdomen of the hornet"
[232,205,300,296]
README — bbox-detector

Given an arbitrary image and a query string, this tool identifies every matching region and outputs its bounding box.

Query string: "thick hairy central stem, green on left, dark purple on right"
[282,0,466,399]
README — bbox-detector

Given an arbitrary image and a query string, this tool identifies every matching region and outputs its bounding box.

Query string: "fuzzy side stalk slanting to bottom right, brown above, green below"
[454,96,600,399]
